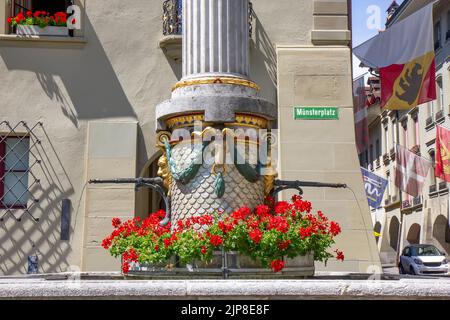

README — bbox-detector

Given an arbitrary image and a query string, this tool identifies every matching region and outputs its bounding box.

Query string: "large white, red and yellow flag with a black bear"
[354,3,436,110]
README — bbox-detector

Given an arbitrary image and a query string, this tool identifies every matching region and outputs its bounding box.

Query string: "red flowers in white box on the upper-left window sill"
[7,11,74,37]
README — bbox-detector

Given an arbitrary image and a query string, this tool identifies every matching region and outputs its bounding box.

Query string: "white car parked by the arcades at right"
[398,244,449,275]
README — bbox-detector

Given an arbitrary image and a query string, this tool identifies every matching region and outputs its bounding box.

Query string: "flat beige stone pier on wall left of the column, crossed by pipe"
[82,121,137,271]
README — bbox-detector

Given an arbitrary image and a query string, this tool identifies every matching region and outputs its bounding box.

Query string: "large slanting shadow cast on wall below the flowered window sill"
[0,18,136,127]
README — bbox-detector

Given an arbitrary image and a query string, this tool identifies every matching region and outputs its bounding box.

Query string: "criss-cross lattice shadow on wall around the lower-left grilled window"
[0,128,77,275]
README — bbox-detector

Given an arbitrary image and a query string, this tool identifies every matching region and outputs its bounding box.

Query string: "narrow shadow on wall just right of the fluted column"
[250,12,277,105]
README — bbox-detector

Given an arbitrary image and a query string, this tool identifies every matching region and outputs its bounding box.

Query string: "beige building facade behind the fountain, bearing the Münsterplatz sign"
[0,0,380,275]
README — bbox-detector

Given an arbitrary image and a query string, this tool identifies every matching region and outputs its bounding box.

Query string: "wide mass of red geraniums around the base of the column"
[102,196,344,274]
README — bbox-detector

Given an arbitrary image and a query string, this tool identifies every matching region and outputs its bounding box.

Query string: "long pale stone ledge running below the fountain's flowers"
[0,278,450,300]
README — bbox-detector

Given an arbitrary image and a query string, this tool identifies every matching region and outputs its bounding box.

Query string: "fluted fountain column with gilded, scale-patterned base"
[156,0,277,225]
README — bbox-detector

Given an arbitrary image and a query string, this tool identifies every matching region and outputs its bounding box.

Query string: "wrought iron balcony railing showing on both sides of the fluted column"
[163,0,253,37]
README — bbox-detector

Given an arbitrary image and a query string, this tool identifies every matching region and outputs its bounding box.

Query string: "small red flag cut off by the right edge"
[434,126,450,182]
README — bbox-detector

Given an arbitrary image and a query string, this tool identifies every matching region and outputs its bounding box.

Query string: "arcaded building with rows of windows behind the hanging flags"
[360,0,450,264]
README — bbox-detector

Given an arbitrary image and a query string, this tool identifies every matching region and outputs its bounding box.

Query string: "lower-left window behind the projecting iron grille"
[0,136,30,209]
